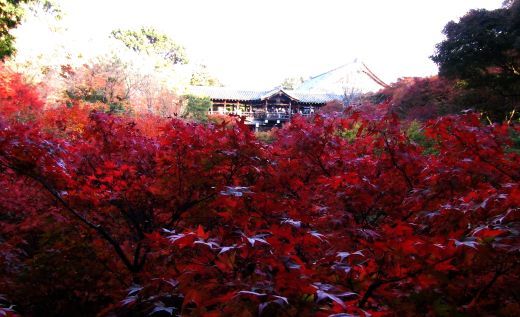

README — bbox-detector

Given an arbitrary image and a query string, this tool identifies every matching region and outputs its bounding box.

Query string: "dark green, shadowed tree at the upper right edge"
[431,0,520,118]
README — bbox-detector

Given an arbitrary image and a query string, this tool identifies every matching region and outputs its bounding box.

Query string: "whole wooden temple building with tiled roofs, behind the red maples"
[188,61,385,128]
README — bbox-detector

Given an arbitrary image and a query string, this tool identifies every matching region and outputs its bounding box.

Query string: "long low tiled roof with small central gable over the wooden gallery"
[188,86,343,104]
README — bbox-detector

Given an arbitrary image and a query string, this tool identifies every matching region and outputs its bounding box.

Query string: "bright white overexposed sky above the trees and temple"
[46,0,503,89]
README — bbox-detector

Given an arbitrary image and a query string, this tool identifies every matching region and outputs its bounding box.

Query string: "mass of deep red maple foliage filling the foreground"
[0,65,520,316]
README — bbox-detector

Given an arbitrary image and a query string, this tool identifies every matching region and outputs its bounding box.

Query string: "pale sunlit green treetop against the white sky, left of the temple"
[112,27,188,64]
